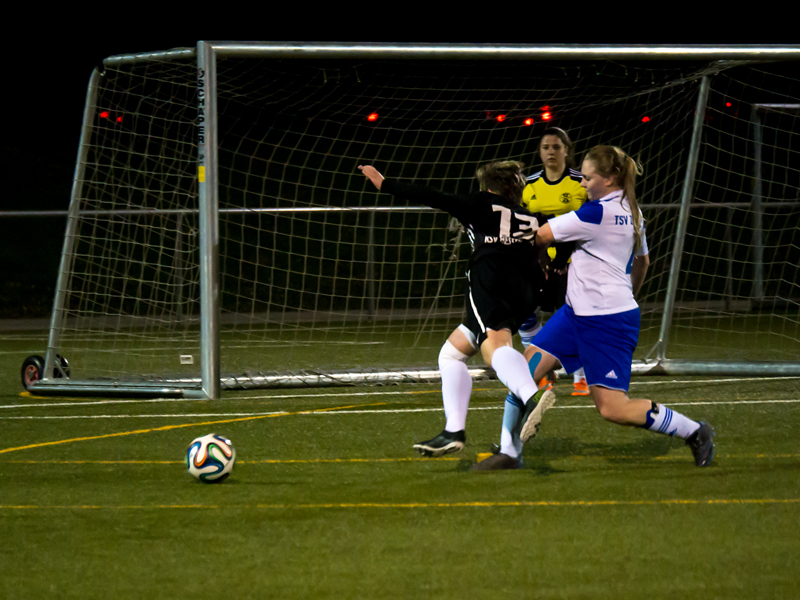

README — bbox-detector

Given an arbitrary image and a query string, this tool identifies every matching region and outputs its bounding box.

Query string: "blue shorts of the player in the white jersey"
[533,304,641,392]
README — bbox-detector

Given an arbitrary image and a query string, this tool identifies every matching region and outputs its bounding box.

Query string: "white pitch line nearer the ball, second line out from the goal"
[0,398,800,421]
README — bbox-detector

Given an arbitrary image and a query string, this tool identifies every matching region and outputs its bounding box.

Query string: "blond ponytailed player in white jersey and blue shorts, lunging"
[484,146,714,469]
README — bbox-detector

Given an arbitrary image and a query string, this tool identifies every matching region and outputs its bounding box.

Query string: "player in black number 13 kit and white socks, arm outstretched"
[358,161,555,468]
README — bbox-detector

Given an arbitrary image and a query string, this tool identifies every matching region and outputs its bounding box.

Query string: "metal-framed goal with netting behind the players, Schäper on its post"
[33,42,800,398]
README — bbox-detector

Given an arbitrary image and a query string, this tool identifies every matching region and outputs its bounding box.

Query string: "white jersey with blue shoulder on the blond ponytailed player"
[549,190,648,317]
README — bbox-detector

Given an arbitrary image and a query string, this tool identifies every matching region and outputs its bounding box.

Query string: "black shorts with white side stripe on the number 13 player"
[464,260,544,346]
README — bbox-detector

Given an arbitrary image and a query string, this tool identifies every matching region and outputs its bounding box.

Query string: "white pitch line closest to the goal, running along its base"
[6,376,800,409]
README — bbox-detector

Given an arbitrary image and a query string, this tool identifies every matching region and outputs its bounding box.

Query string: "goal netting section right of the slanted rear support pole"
[668,64,800,361]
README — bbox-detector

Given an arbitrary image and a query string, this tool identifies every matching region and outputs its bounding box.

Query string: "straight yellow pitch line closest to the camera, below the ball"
[0,498,800,510]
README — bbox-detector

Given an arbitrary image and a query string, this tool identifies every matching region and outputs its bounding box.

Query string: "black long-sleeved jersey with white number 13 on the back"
[381,179,547,271]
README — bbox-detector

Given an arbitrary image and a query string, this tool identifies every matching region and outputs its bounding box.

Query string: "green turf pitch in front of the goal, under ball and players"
[0,326,800,600]
